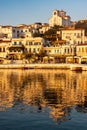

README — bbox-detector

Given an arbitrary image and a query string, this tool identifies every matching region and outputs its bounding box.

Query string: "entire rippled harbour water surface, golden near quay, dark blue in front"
[0,69,87,130]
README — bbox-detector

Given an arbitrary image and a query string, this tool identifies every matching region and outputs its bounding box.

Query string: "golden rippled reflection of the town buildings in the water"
[0,70,87,124]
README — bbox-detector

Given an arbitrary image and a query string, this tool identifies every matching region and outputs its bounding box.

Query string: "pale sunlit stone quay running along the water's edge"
[0,64,87,71]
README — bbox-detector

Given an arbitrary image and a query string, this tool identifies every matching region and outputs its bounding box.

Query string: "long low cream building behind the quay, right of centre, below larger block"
[44,44,76,63]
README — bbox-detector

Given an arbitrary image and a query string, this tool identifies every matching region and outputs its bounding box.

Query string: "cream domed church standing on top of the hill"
[49,10,71,27]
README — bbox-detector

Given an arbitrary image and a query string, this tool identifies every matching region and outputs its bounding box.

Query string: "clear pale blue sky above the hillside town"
[0,0,87,26]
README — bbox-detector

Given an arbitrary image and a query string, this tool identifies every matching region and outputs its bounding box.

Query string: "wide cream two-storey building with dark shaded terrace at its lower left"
[8,37,45,60]
